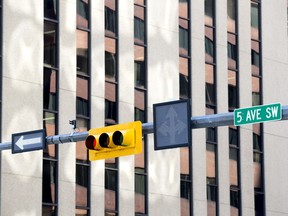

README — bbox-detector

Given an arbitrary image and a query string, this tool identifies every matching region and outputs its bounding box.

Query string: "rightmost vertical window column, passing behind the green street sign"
[251,0,265,216]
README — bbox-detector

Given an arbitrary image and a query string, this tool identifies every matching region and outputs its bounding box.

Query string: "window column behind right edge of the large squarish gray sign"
[178,0,192,216]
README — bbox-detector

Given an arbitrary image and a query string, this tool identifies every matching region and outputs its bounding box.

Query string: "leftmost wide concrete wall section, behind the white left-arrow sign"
[1,0,43,215]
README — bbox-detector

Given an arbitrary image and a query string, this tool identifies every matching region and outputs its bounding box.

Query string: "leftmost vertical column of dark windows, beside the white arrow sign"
[42,0,59,215]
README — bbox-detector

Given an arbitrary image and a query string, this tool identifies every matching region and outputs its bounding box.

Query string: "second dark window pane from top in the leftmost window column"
[44,22,57,68]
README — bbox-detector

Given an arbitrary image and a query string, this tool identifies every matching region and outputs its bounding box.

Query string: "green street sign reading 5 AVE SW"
[234,103,282,126]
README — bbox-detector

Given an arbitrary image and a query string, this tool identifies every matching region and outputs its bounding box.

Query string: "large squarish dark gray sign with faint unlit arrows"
[153,100,191,150]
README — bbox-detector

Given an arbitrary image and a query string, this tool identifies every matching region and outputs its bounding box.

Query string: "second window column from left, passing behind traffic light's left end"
[75,0,91,215]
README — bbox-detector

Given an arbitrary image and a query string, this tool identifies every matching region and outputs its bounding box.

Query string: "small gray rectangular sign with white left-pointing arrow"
[12,130,45,154]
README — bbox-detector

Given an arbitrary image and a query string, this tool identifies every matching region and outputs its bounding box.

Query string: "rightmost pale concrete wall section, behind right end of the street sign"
[262,0,288,216]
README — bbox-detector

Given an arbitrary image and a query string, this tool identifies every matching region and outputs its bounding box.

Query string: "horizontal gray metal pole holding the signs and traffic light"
[0,106,288,151]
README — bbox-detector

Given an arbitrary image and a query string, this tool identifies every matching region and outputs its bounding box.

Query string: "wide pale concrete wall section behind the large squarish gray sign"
[147,0,180,216]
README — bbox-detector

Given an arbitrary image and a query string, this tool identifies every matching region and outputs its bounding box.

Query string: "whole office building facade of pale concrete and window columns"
[0,0,288,216]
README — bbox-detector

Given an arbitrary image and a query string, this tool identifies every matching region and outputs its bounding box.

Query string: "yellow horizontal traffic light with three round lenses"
[85,121,142,161]
